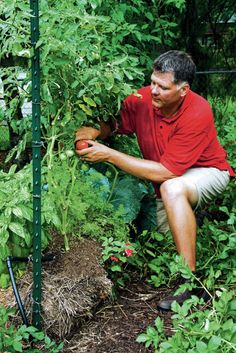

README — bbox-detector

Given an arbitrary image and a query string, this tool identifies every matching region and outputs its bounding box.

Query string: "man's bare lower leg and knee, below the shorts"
[160,177,198,271]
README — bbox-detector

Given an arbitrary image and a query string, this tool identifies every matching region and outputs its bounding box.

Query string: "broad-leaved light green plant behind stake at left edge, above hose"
[0,164,60,288]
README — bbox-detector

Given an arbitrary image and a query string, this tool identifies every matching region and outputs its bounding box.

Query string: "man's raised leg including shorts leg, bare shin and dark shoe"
[157,168,229,310]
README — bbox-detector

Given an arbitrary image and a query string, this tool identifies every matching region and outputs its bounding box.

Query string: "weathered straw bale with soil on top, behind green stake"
[8,239,112,339]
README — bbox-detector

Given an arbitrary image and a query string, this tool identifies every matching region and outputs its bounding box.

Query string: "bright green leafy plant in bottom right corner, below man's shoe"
[137,290,236,353]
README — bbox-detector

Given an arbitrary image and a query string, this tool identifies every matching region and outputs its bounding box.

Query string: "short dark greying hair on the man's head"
[153,50,196,85]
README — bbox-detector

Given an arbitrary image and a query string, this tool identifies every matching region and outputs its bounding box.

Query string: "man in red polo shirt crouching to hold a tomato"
[76,50,235,310]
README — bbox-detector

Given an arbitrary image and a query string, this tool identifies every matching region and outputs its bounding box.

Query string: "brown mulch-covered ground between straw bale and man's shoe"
[60,281,171,353]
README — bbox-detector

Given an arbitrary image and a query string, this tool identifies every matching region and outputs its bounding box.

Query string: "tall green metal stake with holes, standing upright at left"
[30,0,42,330]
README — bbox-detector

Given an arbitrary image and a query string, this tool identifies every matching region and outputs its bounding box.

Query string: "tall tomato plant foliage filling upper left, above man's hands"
[0,0,184,159]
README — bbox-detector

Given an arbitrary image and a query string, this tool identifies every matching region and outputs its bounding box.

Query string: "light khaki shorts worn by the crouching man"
[157,168,230,233]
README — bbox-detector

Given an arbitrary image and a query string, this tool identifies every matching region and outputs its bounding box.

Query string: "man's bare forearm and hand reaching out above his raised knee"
[76,140,177,183]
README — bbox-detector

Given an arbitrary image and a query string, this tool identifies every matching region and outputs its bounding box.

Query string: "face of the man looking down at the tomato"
[151,71,188,114]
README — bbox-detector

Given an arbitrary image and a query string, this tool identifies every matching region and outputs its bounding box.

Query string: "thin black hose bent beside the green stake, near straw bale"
[7,254,55,326]
